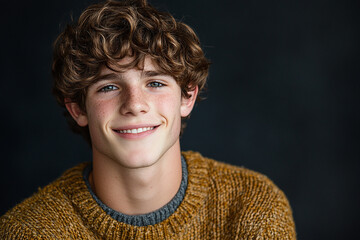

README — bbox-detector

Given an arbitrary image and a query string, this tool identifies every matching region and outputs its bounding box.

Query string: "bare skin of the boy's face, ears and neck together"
[66,57,198,215]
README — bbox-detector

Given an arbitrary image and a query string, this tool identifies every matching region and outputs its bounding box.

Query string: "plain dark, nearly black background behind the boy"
[0,0,360,239]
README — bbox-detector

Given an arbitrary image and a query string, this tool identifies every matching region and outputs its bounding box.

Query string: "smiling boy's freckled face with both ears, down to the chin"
[66,57,197,168]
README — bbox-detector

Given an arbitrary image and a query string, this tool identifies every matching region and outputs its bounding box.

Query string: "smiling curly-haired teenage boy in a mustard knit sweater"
[0,0,295,239]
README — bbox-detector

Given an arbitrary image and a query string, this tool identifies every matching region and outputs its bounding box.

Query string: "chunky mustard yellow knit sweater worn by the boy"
[0,152,296,239]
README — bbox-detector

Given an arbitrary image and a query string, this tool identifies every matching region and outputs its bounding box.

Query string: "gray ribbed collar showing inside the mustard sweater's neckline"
[83,156,188,226]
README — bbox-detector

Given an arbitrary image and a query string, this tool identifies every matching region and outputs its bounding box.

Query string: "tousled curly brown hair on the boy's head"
[52,0,209,144]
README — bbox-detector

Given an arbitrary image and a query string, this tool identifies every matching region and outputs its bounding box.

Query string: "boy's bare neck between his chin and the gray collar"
[89,143,182,215]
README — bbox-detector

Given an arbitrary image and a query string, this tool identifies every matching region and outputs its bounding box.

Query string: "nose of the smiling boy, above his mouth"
[120,86,149,116]
